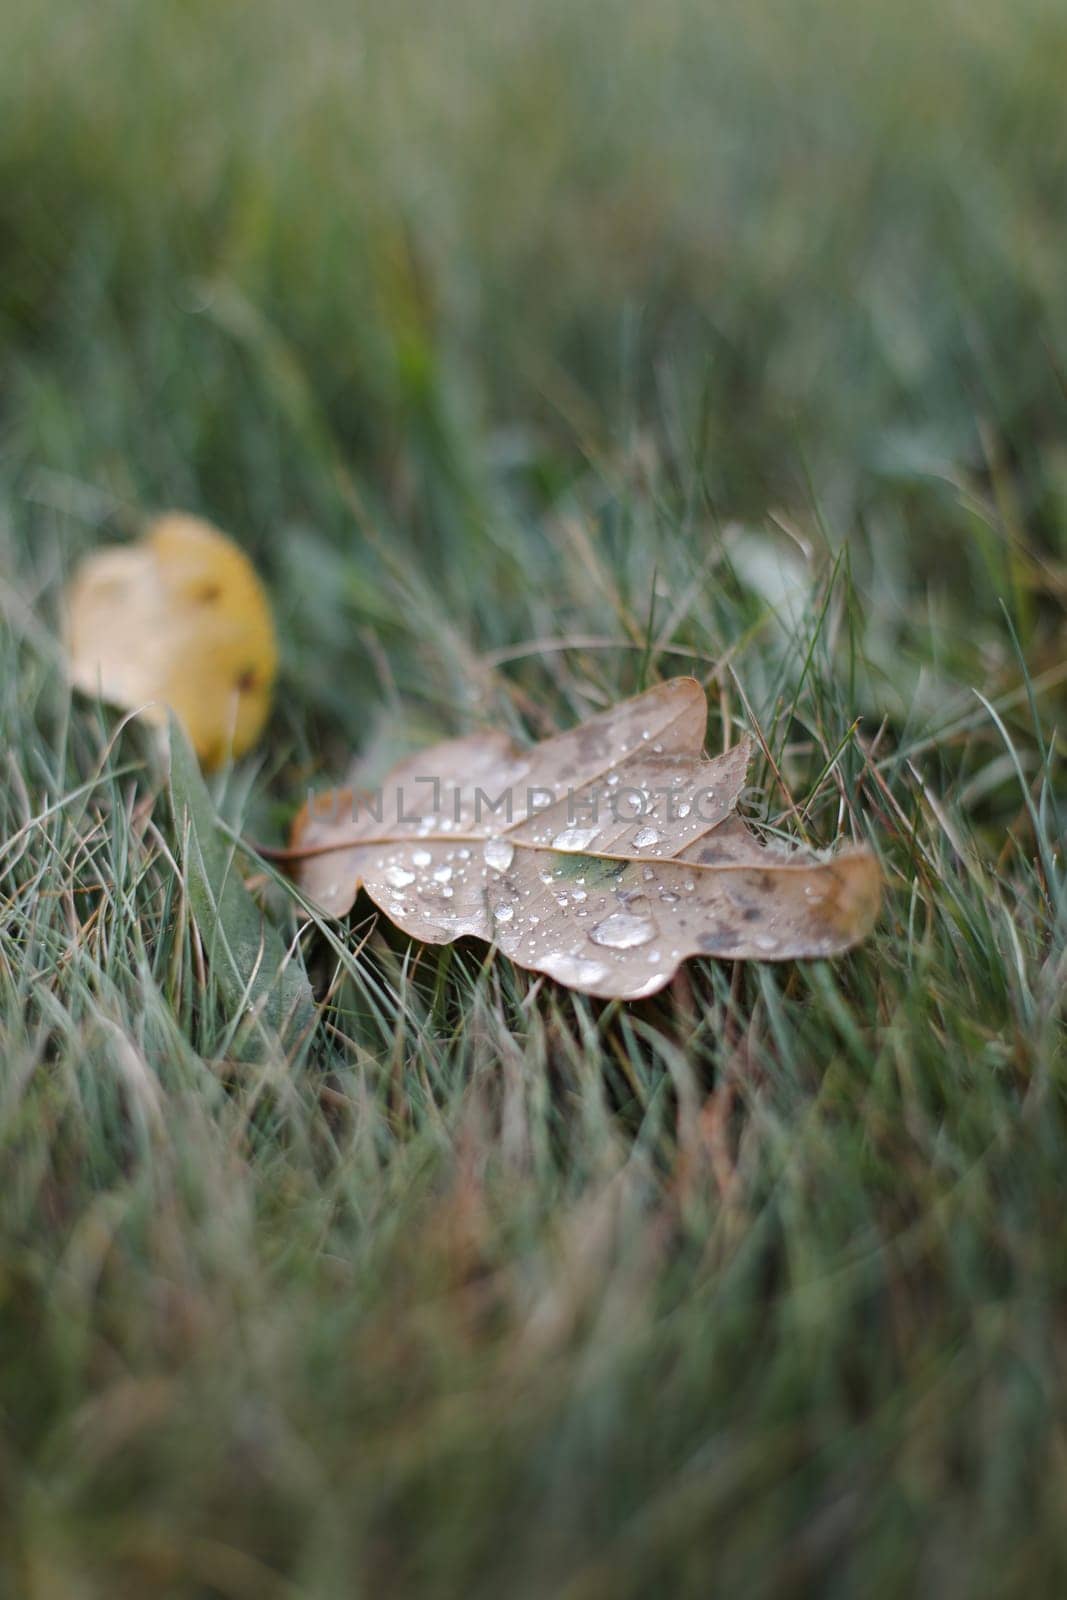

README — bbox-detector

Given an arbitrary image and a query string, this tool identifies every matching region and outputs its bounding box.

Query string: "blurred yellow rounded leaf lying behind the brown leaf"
[66,512,278,766]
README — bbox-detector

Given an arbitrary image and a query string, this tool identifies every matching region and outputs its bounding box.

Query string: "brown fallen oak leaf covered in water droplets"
[282,678,881,1000]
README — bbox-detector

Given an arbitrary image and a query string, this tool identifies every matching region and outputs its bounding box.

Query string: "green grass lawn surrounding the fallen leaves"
[0,0,1067,1600]
